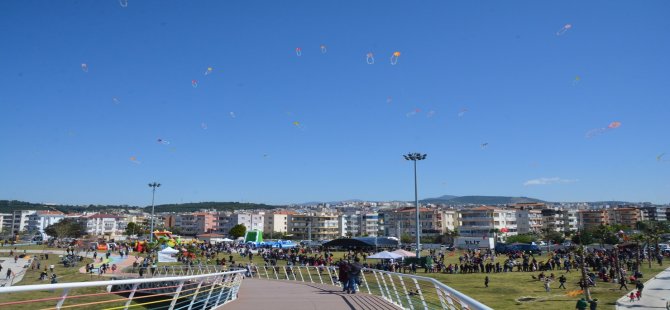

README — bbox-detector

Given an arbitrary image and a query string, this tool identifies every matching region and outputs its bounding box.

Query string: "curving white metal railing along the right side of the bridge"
[252,266,492,310]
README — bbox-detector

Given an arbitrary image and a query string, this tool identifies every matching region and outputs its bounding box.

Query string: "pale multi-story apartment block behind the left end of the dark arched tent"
[288,212,342,240]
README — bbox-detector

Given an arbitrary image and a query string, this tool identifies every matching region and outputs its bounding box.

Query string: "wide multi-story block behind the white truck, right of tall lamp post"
[458,206,518,241]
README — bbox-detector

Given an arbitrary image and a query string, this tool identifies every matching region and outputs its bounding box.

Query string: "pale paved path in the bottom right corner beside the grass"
[616,268,670,310]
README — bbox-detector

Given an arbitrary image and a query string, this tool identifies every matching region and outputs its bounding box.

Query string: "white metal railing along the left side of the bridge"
[0,270,246,310]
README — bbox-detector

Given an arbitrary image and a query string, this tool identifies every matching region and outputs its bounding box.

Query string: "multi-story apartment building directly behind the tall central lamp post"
[380,207,454,238]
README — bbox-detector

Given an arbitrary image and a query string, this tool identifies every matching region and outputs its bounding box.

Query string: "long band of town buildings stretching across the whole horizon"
[0,202,670,243]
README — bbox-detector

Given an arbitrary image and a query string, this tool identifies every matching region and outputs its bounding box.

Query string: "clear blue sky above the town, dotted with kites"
[0,0,670,205]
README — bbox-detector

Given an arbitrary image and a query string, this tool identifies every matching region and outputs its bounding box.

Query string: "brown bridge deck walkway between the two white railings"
[226,278,399,310]
